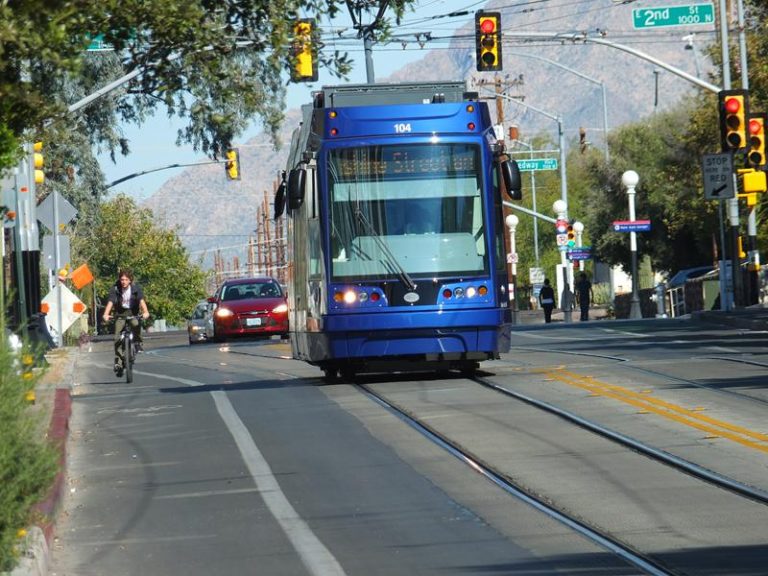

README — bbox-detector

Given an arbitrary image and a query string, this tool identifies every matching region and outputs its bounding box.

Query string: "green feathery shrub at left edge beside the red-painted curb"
[0,332,58,571]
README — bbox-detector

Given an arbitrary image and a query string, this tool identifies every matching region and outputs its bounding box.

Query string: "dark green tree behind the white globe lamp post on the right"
[571,103,718,271]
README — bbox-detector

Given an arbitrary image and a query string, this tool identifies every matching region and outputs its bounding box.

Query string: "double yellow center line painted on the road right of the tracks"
[536,367,768,453]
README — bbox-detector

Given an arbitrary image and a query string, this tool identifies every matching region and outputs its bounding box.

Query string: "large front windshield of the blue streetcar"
[328,143,488,281]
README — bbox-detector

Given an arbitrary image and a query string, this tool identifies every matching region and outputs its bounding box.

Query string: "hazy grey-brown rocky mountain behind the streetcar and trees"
[144,0,715,264]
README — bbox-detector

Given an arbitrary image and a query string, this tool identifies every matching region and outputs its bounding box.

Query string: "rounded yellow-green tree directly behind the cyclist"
[73,195,206,324]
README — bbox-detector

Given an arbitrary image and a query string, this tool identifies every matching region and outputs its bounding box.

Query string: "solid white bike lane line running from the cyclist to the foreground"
[134,370,345,576]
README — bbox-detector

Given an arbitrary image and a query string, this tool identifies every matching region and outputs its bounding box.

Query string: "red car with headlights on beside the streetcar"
[208,277,288,342]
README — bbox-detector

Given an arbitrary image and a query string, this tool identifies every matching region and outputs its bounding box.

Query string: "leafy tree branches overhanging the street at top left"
[0,0,420,169]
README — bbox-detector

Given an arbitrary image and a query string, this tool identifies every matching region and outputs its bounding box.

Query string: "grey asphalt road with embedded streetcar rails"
[50,321,768,576]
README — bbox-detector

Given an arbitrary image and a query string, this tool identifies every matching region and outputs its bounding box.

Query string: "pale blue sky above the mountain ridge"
[99,0,474,201]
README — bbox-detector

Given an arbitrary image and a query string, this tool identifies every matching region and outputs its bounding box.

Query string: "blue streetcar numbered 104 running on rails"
[275,82,521,379]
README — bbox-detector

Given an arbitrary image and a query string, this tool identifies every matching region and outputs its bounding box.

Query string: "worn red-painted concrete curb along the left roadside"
[9,350,76,576]
